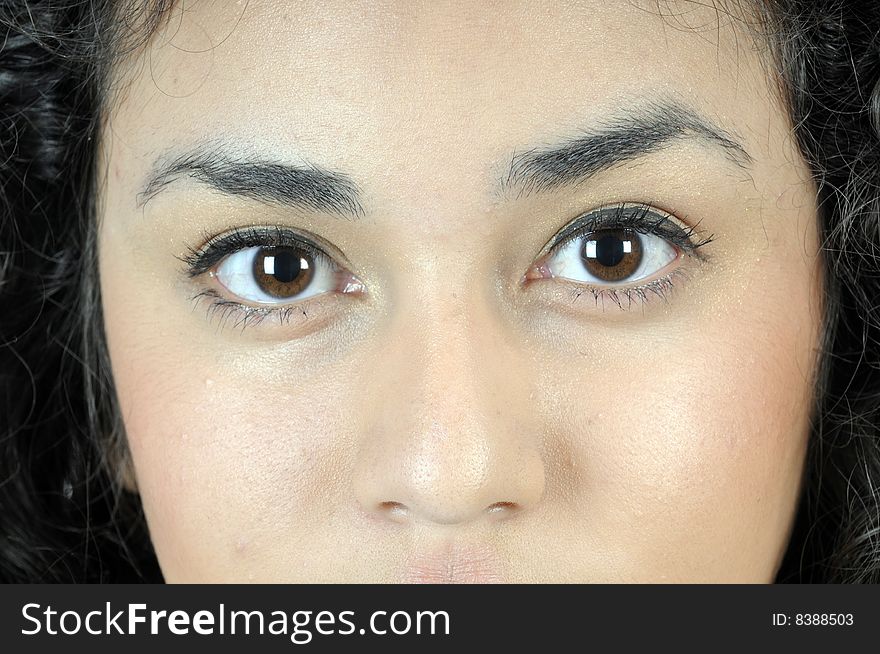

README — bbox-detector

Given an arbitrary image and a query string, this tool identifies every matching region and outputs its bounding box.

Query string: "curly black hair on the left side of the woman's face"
[0,0,169,582]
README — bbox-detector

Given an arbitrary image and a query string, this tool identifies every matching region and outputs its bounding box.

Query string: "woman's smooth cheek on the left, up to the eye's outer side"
[102,258,350,580]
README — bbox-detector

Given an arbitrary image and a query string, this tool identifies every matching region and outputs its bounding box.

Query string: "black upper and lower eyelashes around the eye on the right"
[539,203,715,311]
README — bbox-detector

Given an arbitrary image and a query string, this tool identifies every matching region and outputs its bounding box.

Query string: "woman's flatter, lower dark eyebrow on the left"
[137,144,364,218]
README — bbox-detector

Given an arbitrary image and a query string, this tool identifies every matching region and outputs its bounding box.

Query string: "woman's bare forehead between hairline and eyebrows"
[111,0,779,193]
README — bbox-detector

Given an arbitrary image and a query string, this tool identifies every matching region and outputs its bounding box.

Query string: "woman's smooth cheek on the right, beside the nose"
[548,278,816,581]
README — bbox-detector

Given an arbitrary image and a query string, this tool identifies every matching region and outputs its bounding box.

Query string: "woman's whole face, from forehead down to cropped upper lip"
[100,0,822,582]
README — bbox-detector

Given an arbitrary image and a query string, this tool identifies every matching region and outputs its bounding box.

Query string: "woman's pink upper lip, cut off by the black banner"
[403,544,504,584]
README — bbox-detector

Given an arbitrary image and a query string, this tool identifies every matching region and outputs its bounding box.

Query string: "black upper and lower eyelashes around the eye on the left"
[180,227,333,330]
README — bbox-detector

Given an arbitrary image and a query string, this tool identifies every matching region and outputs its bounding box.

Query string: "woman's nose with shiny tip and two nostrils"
[354,290,545,525]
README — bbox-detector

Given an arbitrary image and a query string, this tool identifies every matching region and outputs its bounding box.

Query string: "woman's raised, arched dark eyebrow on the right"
[500,101,754,195]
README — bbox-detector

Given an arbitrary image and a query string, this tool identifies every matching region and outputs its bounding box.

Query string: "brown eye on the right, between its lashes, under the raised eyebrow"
[535,228,681,286]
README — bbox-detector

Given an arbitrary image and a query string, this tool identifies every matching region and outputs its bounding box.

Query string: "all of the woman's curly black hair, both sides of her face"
[0,0,880,582]
